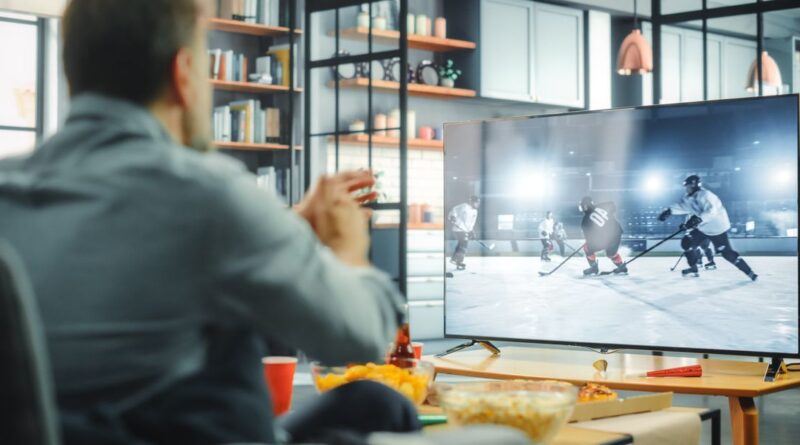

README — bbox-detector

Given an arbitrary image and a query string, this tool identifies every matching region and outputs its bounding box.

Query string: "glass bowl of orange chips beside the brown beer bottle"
[311,359,434,405]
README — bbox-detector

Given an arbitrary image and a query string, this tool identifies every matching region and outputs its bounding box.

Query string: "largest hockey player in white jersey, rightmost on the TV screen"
[658,175,758,281]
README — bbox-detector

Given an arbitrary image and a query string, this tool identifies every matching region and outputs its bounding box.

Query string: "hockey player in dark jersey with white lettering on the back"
[578,196,628,275]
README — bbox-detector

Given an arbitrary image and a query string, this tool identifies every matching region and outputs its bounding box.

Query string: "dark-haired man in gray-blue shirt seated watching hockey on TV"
[0,0,419,444]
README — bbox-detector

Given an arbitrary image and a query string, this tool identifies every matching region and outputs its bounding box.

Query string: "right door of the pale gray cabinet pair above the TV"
[533,3,585,108]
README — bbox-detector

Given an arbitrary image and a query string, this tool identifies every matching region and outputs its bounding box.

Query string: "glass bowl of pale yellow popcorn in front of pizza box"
[439,381,578,445]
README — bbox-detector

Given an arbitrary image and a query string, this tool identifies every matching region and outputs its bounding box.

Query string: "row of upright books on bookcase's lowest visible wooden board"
[213,99,281,144]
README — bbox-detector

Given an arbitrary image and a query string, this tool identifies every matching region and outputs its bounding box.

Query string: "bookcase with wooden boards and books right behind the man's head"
[207,0,303,205]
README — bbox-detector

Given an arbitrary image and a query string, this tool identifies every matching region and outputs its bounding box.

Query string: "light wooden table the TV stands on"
[425,347,800,445]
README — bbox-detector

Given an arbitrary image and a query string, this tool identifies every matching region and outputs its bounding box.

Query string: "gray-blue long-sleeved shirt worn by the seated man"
[0,95,402,409]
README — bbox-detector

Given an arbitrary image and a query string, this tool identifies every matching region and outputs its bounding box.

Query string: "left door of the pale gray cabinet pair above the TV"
[480,0,534,102]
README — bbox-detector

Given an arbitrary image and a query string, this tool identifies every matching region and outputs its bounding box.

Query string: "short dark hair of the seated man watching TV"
[63,0,200,105]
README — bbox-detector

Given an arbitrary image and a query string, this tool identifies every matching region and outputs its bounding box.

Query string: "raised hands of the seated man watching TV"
[295,171,377,266]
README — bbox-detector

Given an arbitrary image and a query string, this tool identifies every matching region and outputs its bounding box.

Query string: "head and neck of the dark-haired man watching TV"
[63,0,211,149]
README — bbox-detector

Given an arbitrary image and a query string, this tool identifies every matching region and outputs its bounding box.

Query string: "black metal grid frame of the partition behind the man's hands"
[303,0,408,295]
